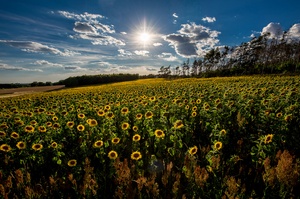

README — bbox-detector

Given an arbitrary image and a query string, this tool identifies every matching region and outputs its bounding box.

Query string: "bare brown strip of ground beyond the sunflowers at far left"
[0,85,65,98]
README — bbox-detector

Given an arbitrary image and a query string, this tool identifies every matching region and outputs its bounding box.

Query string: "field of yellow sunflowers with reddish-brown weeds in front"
[0,76,300,199]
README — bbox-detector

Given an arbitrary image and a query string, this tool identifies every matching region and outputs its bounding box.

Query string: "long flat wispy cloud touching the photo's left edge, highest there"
[0,40,79,56]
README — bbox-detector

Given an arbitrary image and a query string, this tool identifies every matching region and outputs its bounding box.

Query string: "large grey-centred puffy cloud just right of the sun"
[164,22,220,57]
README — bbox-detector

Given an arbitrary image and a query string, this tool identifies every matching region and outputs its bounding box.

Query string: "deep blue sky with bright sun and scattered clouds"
[0,0,300,83]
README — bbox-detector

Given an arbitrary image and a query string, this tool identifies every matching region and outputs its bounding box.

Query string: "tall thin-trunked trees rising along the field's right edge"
[158,32,300,77]
